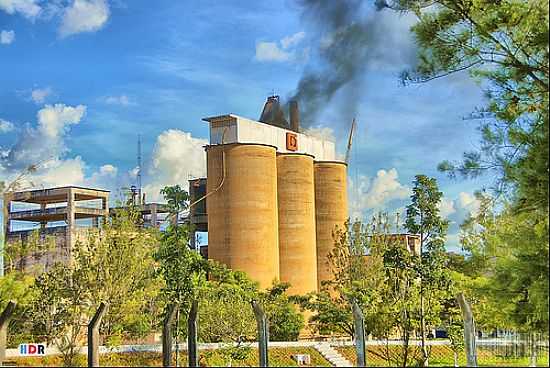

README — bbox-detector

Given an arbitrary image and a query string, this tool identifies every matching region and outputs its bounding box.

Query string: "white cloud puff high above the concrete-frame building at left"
[37,104,86,138]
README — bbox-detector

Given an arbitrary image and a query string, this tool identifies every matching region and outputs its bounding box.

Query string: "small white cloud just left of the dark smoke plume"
[254,32,308,62]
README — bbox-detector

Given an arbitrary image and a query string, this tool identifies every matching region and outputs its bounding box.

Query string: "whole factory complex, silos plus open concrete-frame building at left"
[4,96,419,294]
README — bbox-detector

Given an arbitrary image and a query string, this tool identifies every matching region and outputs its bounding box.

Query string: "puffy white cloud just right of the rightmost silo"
[349,168,411,218]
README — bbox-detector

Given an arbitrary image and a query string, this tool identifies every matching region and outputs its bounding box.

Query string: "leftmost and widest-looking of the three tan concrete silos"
[206,144,279,288]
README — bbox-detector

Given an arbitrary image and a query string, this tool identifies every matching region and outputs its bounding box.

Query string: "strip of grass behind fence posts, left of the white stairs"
[8,347,330,367]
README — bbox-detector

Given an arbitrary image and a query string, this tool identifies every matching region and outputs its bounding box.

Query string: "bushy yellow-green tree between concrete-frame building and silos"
[74,208,164,345]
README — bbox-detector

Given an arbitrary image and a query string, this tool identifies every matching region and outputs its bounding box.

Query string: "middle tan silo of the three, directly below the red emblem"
[277,153,317,294]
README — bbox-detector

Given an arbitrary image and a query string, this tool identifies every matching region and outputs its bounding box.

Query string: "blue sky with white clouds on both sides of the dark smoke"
[0,0,492,247]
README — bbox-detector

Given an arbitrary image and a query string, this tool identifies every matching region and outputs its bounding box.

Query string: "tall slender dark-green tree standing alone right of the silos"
[405,175,449,366]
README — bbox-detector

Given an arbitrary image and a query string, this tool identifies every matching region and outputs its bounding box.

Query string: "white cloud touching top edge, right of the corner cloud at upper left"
[59,0,109,37]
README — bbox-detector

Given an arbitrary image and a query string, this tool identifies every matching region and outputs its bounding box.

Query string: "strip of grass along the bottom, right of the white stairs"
[336,345,548,367]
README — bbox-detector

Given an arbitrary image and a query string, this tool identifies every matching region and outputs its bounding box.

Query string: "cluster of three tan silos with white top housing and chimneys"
[196,96,348,294]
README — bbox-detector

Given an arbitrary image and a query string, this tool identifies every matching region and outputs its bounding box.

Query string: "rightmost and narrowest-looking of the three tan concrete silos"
[314,161,348,288]
